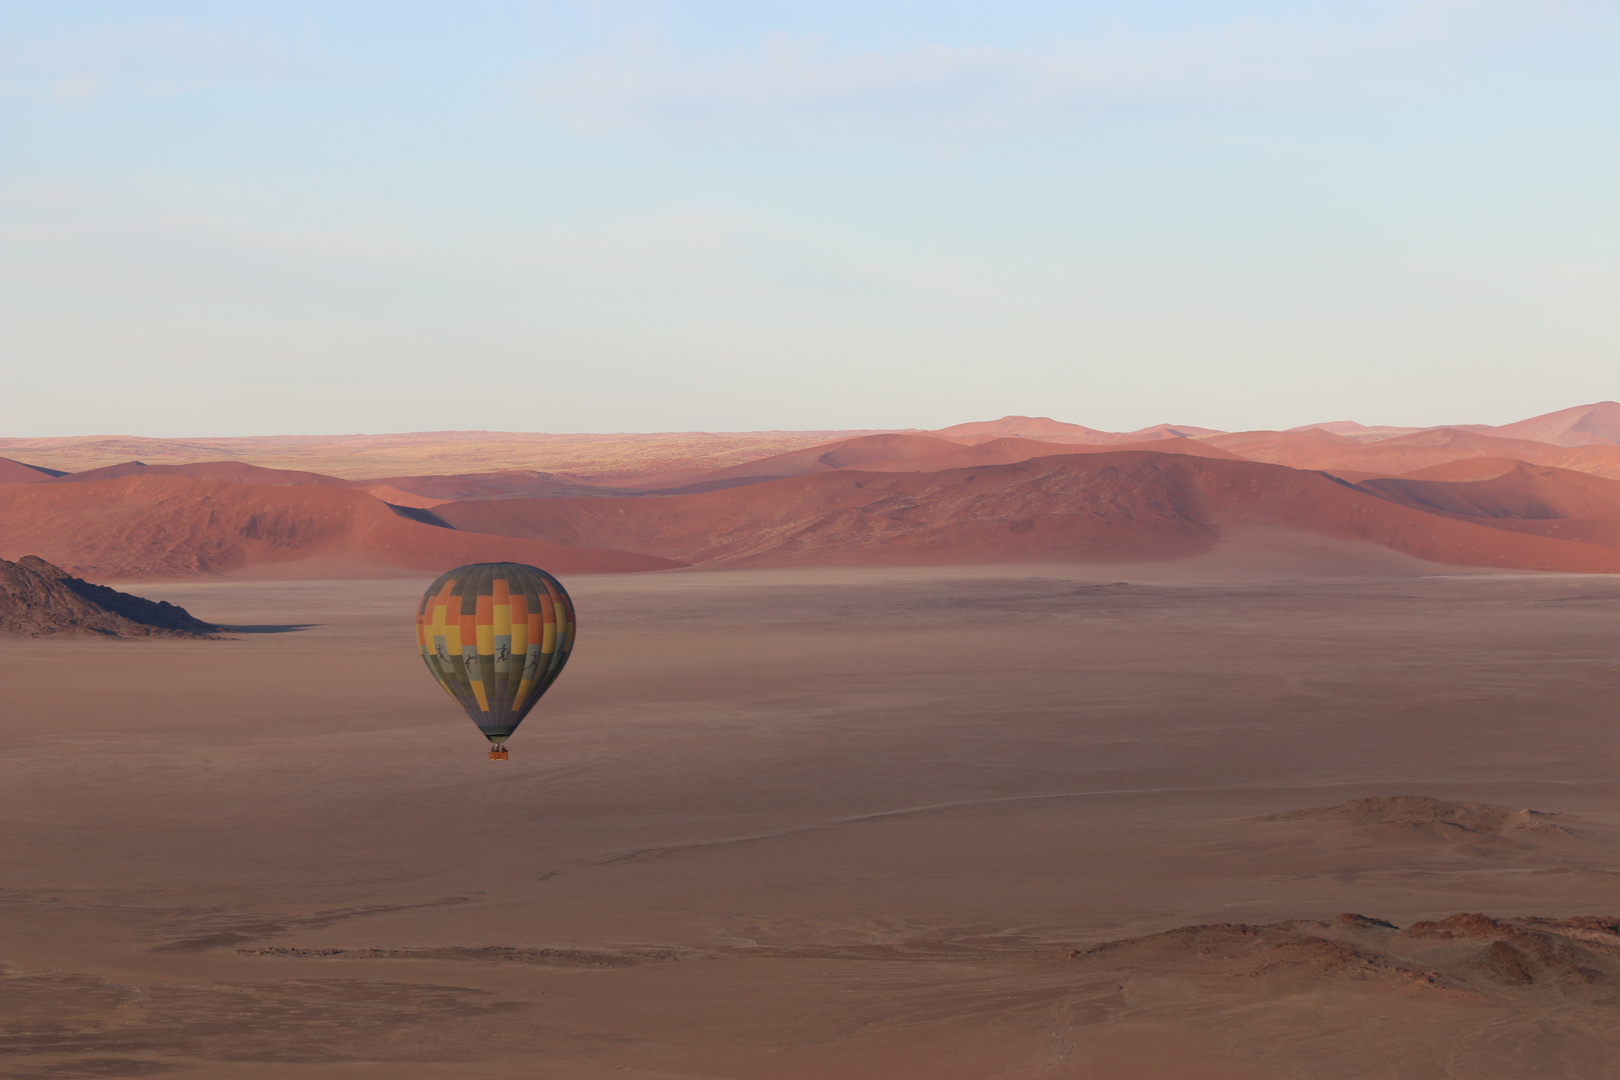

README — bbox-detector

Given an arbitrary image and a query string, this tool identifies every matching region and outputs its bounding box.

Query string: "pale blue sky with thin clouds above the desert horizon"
[0,0,1620,436]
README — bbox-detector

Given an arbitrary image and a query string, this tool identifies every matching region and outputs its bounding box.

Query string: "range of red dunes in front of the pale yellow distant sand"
[12,446,1620,578]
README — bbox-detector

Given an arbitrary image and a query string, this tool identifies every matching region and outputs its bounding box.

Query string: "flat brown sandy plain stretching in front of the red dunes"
[0,563,1620,1080]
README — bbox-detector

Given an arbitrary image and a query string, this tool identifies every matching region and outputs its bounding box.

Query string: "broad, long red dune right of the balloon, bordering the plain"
[436,452,1620,573]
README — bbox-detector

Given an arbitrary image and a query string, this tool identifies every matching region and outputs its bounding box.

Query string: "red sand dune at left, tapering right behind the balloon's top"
[0,474,674,580]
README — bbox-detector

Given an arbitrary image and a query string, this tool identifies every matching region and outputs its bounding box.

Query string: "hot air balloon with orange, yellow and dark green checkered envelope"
[416,562,573,761]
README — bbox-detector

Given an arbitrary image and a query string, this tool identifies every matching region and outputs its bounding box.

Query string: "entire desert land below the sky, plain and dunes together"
[0,409,1620,1080]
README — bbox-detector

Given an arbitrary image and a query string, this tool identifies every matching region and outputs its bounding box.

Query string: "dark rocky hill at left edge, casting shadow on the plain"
[0,555,219,638]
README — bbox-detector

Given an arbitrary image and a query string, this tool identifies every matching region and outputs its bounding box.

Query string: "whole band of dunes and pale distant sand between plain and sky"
[9,402,1620,580]
